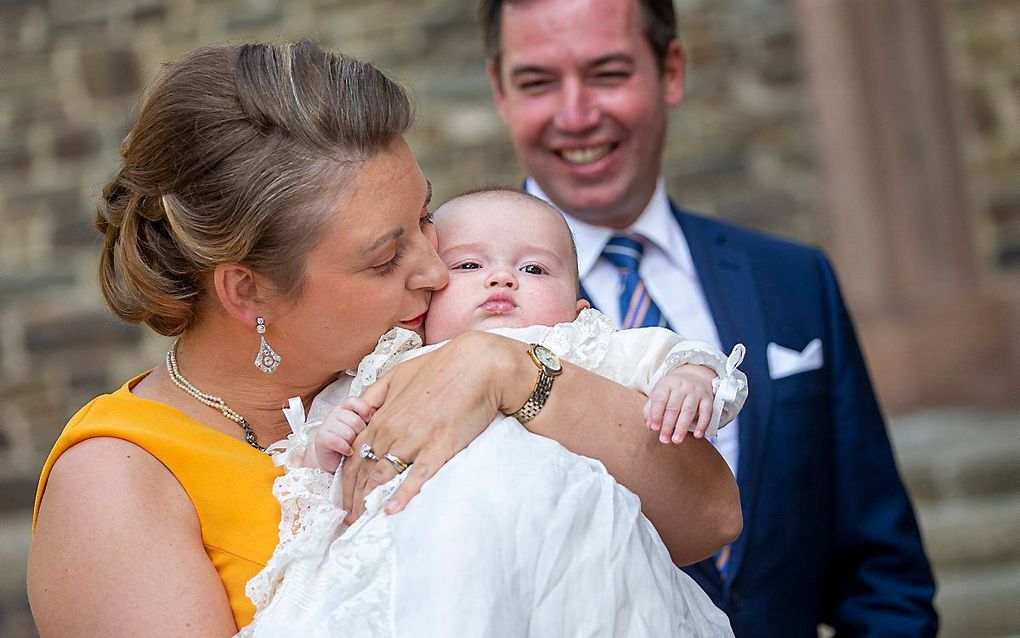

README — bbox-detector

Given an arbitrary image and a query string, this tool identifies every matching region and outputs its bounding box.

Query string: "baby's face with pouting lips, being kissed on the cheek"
[425,193,587,343]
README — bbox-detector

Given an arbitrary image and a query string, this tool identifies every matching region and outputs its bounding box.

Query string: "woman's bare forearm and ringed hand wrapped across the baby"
[344,333,742,565]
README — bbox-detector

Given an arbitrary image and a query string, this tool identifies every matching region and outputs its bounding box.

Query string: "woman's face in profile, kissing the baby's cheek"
[267,140,448,375]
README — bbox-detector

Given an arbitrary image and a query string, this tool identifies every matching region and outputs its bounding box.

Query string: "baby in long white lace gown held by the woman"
[242,189,747,638]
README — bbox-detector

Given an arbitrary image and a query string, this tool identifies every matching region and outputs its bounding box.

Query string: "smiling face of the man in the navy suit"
[489,0,683,229]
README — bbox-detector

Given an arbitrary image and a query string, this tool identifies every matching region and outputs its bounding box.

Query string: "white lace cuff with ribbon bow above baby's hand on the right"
[652,339,748,437]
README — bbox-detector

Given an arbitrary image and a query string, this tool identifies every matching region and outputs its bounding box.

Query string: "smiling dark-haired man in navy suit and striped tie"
[479,0,937,637]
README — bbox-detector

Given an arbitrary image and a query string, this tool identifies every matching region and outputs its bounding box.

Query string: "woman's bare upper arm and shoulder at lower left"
[29,438,237,638]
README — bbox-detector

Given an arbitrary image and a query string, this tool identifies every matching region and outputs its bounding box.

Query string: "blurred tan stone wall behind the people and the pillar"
[0,0,1020,636]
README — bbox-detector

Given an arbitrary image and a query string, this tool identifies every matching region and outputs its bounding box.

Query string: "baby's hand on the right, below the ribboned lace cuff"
[644,363,715,443]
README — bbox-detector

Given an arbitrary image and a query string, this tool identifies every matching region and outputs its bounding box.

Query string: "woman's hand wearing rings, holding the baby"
[343,332,533,523]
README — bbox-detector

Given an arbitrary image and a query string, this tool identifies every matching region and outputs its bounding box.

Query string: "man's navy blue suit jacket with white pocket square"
[587,206,937,638]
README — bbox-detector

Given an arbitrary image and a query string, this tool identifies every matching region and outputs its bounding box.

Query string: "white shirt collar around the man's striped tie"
[524,178,695,280]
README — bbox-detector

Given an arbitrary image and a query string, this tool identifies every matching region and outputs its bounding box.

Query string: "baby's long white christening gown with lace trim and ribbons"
[240,311,747,638]
